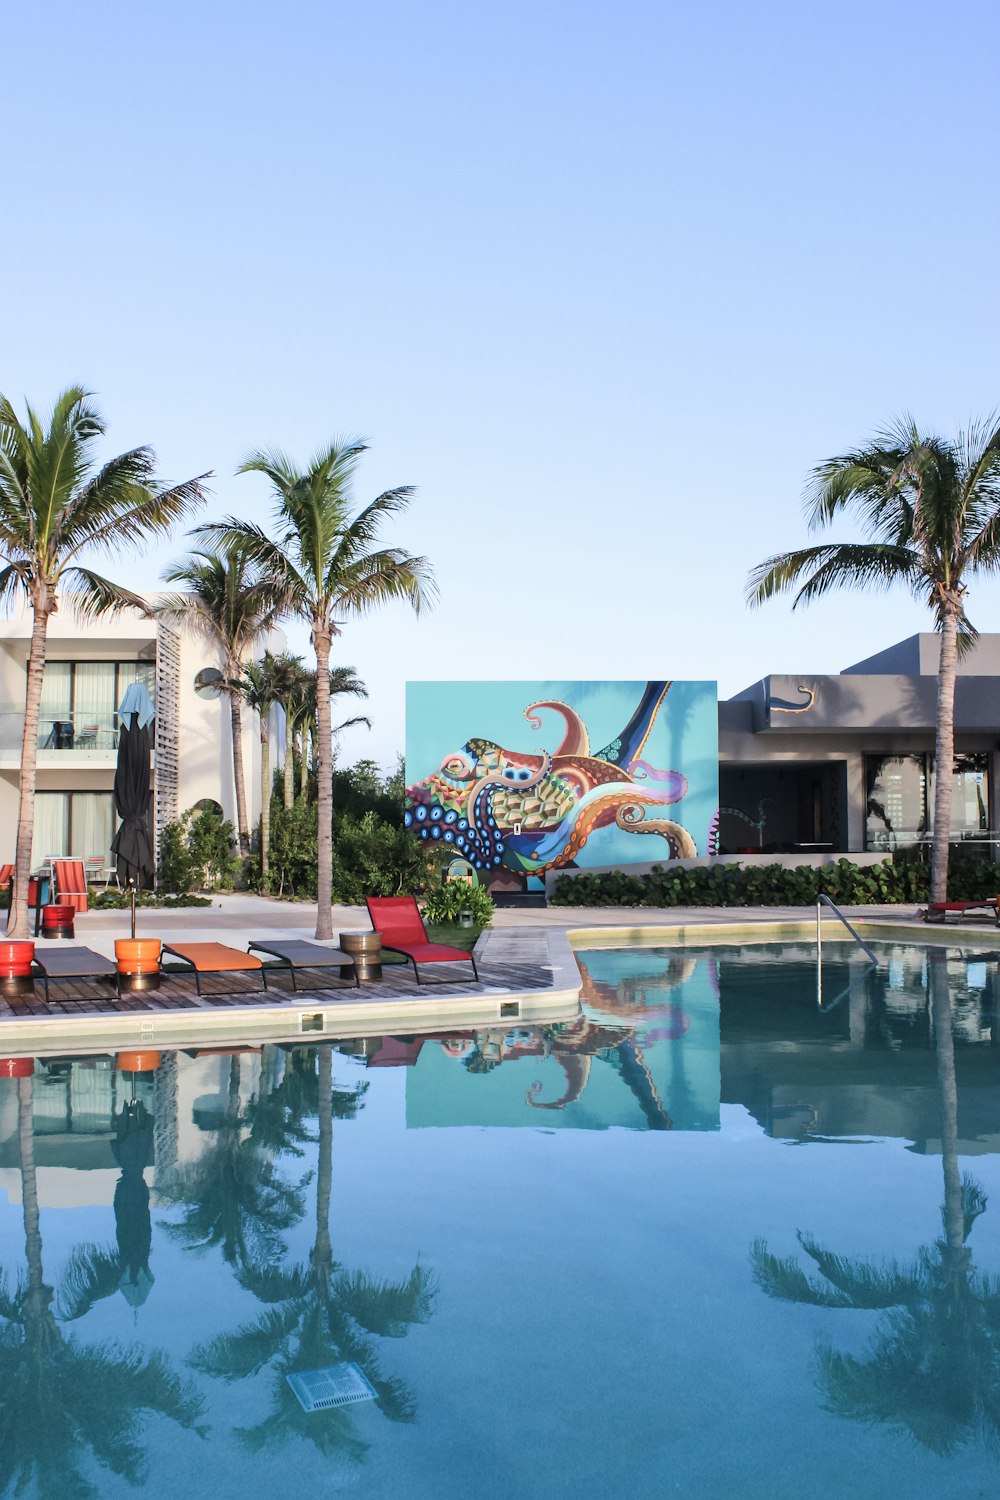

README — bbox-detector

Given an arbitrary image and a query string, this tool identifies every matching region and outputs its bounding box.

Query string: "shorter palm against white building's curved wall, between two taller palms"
[156,546,280,858]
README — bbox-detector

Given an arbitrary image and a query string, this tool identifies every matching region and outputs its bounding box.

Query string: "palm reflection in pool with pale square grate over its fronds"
[192,1047,435,1461]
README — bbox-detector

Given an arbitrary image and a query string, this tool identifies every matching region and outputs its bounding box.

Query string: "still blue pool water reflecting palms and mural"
[0,947,1000,1500]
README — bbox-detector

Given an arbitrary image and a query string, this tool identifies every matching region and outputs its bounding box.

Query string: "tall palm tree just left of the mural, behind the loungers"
[198,438,435,938]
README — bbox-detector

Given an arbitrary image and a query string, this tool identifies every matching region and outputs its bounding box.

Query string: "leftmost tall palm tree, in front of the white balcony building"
[0,386,208,938]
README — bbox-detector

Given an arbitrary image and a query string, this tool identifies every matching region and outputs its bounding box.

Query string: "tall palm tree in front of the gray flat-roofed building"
[747,416,1000,902]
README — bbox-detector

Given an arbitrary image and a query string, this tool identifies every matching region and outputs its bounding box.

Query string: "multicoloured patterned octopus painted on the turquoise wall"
[405,683,699,876]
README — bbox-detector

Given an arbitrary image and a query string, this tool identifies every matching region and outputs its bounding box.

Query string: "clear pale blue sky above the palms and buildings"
[0,0,1000,761]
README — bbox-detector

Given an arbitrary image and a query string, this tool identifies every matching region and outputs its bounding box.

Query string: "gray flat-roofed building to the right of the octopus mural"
[718,633,1000,854]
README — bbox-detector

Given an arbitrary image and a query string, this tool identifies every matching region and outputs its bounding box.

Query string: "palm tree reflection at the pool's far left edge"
[0,1079,204,1500]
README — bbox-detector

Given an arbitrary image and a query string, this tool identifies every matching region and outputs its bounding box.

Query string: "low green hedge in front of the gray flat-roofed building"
[550,860,1000,906]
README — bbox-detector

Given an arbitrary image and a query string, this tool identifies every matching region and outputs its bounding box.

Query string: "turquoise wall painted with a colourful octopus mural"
[406,681,718,885]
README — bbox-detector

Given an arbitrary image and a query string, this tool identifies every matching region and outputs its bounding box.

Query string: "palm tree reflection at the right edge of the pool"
[751,954,1000,1455]
